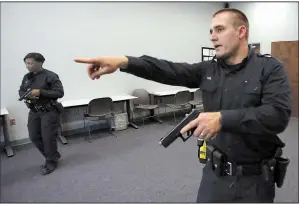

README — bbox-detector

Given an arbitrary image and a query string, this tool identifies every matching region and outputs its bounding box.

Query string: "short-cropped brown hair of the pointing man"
[213,8,249,39]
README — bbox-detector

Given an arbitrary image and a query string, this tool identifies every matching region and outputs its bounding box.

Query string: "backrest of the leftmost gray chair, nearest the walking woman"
[88,97,113,115]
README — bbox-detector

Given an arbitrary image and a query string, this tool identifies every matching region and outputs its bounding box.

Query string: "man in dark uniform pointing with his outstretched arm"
[75,9,291,202]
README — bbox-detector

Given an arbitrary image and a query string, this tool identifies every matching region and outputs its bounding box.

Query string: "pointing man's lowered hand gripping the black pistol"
[180,112,221,140]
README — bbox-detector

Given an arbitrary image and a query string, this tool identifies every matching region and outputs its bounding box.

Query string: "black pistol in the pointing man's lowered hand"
[159,109,199,148]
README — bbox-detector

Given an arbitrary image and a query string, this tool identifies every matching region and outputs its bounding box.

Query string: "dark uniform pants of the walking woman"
[28,110,60,162]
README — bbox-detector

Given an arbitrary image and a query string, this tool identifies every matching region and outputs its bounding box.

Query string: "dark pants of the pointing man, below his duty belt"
[197,163,275,203]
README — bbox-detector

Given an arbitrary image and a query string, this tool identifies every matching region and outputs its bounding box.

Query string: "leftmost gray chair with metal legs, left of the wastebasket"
[83,97,115,142]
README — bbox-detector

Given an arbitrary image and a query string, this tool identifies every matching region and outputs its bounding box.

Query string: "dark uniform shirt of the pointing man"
[120,46,291,164]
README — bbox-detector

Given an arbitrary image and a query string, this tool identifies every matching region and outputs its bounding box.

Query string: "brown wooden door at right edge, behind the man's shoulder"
[271,40,299,118]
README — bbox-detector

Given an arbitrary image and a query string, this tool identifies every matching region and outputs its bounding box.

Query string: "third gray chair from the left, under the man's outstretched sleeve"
[165,91,191,122]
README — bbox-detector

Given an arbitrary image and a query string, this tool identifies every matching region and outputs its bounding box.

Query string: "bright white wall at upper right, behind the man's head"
[229,2,298,54]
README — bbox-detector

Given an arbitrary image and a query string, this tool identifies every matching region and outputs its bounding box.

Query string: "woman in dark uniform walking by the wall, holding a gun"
[19,53,64,175]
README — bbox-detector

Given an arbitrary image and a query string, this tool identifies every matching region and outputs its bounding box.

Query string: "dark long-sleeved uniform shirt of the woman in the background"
[19,69,64,103]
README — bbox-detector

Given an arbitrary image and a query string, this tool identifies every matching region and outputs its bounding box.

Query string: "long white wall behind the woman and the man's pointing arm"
[1,2,223,140]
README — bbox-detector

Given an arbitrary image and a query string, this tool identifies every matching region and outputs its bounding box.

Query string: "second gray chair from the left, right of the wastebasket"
[132,89,160,125]
